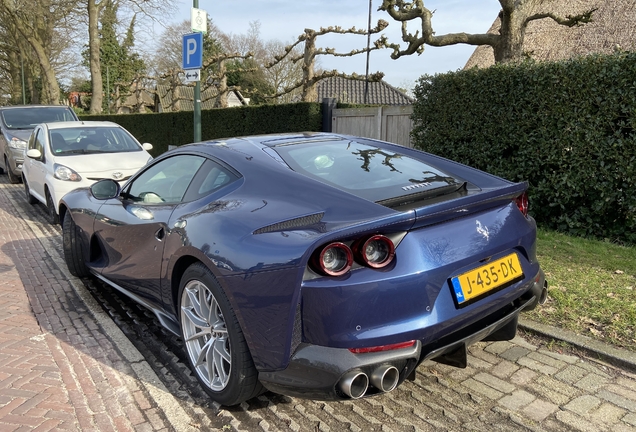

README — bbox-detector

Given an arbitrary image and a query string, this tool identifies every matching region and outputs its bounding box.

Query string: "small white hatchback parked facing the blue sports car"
[22,121,152,223]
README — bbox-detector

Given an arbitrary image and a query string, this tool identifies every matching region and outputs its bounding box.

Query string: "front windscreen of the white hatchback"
[49,126,142,156]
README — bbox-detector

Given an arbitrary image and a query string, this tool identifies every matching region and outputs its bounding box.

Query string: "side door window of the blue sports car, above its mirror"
[125,155,205,204]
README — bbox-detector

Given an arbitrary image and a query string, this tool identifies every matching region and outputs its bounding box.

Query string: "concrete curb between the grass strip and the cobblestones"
[519,317,636,372]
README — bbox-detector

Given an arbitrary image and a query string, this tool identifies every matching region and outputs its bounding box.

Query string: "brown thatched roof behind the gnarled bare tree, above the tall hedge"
[464,0,636,69]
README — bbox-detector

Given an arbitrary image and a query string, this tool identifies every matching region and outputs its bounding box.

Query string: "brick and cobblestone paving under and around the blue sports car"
[0,176,636,432]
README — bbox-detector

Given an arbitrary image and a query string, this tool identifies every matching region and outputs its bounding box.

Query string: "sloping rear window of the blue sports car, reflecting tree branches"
[274,139,463,202]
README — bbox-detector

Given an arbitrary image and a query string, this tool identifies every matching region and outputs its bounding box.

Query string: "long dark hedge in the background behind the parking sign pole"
[80,102,322,156]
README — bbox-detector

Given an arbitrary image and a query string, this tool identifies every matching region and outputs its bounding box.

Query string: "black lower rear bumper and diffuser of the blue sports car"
[259,280,545,400]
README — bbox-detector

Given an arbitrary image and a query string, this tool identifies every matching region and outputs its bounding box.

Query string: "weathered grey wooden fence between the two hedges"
[331,105,413,147]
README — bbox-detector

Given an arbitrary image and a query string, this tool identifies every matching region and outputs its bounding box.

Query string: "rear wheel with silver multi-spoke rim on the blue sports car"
[179,263,264,406]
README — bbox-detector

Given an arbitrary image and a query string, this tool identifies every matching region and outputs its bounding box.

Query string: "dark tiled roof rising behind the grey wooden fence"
[316,77,414,105]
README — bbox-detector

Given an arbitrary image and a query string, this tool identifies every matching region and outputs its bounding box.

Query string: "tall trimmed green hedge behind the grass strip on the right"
[412,52,636,243]
